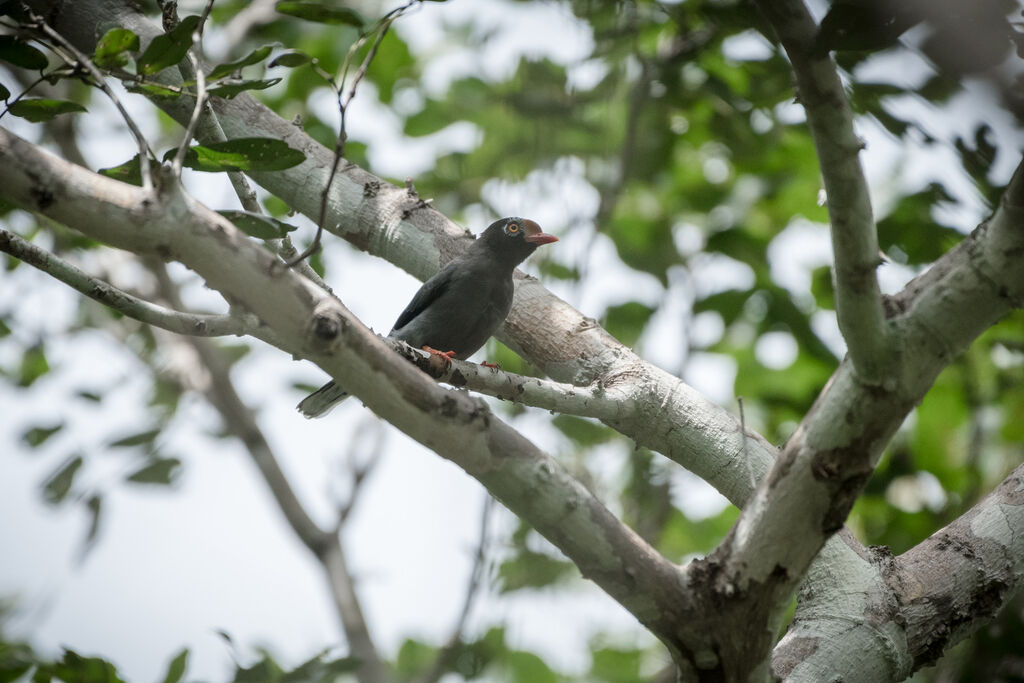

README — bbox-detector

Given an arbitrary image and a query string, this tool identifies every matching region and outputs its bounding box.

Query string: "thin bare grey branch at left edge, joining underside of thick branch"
[0,229,253,337]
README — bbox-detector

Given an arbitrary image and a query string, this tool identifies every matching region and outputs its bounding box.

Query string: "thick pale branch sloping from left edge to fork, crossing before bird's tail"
[0,129,695,654]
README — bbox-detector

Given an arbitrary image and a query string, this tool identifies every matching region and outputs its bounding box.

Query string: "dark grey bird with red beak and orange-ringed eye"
[296,216,558,418]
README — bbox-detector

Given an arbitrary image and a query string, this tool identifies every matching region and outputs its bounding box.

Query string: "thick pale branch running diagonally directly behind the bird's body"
[24,0,776,505]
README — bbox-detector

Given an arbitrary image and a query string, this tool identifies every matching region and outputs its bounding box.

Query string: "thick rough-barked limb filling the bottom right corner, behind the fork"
[772,465,1024,683]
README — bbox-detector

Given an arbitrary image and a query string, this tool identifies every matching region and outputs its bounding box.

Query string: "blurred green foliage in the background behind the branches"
[0,0,1024,681]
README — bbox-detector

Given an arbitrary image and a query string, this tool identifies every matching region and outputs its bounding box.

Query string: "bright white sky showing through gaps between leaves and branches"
[0,0,1013,681]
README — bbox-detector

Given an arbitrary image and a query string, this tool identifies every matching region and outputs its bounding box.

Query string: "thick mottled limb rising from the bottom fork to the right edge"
[687,158,1024,679]
